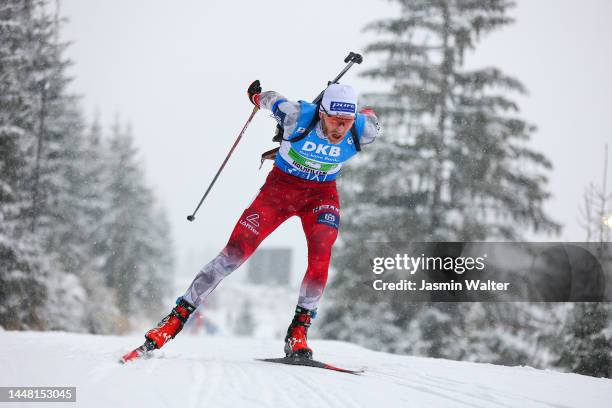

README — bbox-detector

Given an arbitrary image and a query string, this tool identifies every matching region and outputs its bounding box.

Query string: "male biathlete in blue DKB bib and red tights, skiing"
[123,81,379,361]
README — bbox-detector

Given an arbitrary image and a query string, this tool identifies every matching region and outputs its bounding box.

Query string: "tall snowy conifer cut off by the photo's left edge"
[0,0,47,329]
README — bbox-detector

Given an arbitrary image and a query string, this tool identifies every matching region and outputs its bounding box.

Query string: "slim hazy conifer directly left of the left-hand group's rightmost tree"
[61,117,118,333]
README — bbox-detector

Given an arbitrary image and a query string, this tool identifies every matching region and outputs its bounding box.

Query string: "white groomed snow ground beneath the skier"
[0,331,612,408]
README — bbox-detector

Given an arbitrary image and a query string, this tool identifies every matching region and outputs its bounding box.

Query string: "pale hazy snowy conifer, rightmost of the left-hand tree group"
[100,121,172,322]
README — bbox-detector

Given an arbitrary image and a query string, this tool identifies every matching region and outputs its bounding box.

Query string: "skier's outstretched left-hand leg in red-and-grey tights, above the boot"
[183,184,293,307]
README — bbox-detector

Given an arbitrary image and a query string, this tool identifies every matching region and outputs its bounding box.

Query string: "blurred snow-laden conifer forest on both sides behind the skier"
[0,0,612,377]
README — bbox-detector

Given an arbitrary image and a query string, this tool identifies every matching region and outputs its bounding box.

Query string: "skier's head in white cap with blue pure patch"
[319,84,357,144]
